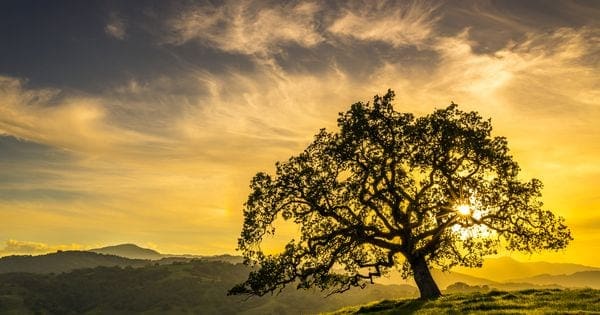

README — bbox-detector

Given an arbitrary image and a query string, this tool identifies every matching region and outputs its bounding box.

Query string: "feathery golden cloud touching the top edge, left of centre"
[167,1,323,55]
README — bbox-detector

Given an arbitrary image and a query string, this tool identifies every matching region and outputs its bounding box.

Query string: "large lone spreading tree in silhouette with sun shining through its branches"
[229,90,572,298]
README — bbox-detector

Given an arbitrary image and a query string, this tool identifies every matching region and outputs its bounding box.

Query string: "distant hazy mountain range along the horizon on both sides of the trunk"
[0,244,600,290]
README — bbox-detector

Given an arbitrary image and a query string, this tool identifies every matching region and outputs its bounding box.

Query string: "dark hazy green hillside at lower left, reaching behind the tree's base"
[0,260,417,314]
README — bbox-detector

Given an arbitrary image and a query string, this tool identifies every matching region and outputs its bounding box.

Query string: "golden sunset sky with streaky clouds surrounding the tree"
[0,1,600,266]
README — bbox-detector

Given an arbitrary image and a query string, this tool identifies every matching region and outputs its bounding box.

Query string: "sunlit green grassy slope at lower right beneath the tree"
[329,289,600,315]
